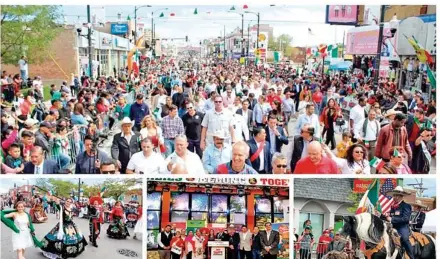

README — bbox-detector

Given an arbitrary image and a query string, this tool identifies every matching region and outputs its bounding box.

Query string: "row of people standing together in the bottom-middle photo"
[157,222,280,259]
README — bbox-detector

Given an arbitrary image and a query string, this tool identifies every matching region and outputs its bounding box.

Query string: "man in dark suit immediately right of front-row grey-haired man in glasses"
[247,127,272,174]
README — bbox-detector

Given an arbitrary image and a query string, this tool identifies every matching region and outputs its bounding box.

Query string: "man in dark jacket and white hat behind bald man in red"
[290,124,319,172]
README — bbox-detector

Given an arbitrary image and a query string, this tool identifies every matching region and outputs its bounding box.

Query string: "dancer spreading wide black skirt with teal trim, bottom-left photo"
[41,196,87,259]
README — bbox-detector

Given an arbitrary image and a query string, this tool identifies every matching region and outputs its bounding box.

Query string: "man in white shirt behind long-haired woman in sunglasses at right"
[354,109,380,160]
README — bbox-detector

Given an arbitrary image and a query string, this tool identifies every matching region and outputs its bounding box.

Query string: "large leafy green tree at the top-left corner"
[1,5,61,64]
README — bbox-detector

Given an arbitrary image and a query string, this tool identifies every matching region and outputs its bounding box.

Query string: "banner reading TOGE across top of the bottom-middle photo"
[148,177,289,187]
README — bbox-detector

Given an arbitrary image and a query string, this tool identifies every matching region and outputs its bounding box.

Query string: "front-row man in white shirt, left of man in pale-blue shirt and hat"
[162,135,206,175]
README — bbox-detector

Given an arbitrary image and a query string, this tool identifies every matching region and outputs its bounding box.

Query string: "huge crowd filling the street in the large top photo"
[1,57,436,175]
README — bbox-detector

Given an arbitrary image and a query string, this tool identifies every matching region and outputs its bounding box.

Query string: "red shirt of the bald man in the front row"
[294,156,340,174]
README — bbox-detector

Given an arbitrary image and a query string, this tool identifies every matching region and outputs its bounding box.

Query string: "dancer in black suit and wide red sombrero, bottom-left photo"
[88,196,104,247]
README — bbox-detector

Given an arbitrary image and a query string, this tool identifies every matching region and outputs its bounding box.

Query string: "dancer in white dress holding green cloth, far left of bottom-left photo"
[1,201,41,259]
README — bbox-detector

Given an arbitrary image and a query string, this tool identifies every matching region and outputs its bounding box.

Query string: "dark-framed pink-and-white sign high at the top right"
[325,5,359,25]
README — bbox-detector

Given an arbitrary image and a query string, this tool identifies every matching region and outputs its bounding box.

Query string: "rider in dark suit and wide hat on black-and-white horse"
[380,186,414,259]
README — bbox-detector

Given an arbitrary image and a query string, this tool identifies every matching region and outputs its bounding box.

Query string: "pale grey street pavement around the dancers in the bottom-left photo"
[1,208,142,259]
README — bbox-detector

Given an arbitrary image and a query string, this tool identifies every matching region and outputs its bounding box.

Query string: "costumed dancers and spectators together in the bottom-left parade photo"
[1,192,143,259]
